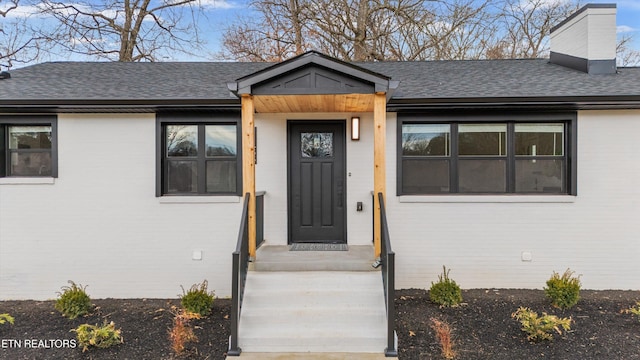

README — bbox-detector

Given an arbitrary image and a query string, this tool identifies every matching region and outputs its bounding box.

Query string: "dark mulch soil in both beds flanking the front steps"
[0,289,640,360]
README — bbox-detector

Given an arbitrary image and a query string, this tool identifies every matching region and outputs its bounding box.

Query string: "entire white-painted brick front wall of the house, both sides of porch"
[0,111,640,299]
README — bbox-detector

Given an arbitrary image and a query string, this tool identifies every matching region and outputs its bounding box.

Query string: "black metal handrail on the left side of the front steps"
[227,193,251,356]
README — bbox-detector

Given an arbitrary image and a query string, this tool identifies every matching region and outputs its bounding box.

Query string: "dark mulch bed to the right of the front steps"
[396,289,640,360]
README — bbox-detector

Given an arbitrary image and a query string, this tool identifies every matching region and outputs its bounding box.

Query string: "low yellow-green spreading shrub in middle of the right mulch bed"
[511,306,572,341]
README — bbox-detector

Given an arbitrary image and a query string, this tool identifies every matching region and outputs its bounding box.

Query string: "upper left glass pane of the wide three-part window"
[402,124,451,156]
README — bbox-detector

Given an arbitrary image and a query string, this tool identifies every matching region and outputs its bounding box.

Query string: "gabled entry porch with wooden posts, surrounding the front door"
[229,52,397,258]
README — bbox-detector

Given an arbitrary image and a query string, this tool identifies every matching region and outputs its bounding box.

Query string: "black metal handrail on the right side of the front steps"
[378,193,398,357]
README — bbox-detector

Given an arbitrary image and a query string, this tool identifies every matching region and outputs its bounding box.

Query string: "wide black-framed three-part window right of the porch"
[398,114,577,195]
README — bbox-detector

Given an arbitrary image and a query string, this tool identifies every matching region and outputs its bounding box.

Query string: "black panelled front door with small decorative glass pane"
[288,121,347,243]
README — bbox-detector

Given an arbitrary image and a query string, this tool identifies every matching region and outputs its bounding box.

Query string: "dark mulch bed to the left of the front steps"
[0,299,231,360]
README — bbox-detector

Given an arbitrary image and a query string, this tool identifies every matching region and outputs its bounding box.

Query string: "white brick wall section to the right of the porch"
[387,111,640,289]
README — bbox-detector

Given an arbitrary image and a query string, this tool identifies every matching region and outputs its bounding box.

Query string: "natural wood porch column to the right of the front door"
[373,93,387,257]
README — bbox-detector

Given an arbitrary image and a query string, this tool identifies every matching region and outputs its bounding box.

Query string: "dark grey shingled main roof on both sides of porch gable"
[0,59,640,107]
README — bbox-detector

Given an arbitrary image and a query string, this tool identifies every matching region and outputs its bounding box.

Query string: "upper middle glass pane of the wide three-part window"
[458,124,507,156]
